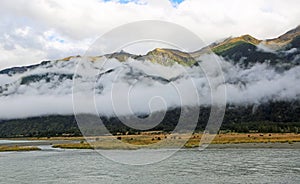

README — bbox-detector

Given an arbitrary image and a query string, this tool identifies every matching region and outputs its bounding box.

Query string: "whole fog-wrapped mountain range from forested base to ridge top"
[0,26,300,137]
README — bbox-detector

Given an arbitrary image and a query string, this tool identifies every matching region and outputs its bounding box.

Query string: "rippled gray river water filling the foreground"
[0,147,300,184]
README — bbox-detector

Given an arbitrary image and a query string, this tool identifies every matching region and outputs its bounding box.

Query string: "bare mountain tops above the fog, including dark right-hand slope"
[0,25,300,74]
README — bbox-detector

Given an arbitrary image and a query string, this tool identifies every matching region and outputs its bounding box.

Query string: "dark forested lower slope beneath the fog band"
[0,101,300,137]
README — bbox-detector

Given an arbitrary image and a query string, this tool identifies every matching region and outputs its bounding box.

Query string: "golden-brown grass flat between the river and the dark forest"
[53,133,300,149]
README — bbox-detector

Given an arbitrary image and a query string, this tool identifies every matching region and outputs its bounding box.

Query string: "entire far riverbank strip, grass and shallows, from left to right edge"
[0,133,300,151]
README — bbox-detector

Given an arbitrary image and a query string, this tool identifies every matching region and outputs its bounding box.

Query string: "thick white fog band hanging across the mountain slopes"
[0,48,300,119]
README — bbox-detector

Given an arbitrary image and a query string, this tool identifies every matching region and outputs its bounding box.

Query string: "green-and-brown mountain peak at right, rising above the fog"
[193,26,300,67]
